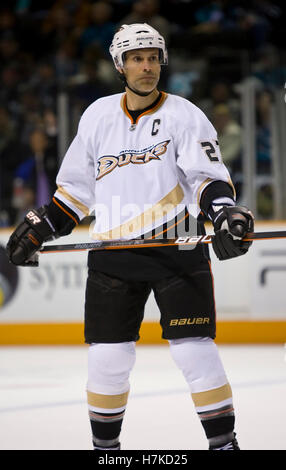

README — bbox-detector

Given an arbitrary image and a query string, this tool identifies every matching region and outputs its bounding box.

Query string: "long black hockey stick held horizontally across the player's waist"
[39,230,286,254]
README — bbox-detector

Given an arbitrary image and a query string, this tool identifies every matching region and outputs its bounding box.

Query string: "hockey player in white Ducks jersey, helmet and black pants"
[7,24,254,450]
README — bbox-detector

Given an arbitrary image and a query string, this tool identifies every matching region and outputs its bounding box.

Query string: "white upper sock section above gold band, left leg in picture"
[87,342,135,395]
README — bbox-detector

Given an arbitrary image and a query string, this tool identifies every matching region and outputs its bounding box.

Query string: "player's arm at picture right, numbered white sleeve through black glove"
[177,109,254,260]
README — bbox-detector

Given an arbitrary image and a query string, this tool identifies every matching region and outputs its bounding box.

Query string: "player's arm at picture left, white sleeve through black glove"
[6,115,94,266]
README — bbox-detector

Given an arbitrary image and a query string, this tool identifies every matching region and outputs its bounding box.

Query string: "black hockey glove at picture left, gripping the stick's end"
[6,206,58,266]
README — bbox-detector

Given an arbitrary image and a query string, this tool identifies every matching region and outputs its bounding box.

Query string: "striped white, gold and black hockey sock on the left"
[87,342,135,450]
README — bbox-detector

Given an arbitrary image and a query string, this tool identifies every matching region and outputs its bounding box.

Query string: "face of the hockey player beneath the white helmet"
[123,48,161,93]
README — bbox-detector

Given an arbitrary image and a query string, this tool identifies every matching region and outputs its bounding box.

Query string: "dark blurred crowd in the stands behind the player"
[0,0,286,227]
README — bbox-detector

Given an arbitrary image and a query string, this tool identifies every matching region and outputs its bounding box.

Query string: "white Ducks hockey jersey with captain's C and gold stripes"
[55,93,232,240]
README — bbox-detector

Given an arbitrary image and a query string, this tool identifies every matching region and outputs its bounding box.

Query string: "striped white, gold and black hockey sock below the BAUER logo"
[169,338,234,447]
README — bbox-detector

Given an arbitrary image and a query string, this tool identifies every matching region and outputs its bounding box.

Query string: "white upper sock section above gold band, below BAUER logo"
[169,337,228,394]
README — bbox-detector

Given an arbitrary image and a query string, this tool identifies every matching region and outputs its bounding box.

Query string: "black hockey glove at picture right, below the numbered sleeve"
[212,206,254,260]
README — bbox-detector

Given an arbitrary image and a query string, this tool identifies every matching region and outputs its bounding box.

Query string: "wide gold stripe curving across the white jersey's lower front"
[92,184,184,240]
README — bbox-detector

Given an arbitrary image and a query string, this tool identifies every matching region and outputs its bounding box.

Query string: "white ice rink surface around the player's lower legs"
[0,345,286,450]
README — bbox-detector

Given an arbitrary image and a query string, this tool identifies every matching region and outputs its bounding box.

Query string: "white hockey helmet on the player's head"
[109,23,168,69]
